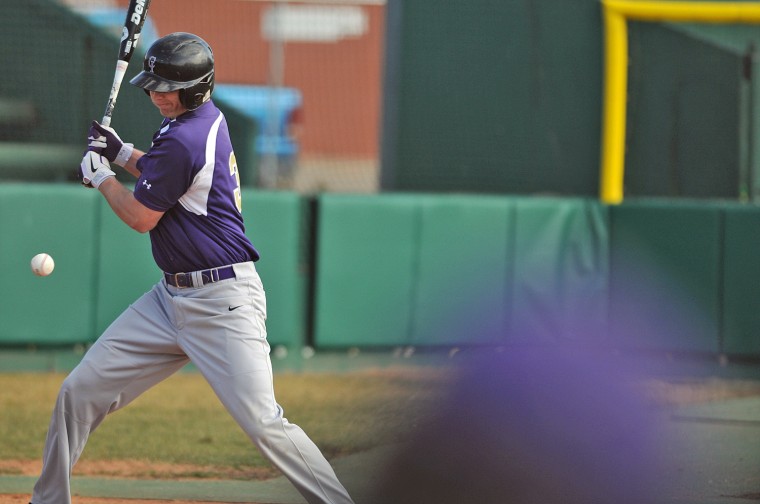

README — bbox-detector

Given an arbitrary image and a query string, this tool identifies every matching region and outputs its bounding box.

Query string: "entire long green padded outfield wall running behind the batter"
[0,184,760,356]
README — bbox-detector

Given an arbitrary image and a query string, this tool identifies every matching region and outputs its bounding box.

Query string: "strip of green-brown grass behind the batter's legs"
[0,370,444,476]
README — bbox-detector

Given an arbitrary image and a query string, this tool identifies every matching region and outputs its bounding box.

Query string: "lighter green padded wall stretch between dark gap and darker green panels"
[315,194,609,347]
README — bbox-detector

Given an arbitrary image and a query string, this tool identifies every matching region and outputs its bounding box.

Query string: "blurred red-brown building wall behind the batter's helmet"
[119,0,385,161]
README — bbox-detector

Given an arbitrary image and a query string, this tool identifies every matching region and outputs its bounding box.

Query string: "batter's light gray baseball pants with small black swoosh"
[32,262,353,504]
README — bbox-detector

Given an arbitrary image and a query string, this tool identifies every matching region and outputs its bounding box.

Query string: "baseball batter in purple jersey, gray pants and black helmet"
[32,33,352,504]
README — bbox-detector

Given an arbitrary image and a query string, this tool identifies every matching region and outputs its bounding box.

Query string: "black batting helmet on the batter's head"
[129,32,214,110]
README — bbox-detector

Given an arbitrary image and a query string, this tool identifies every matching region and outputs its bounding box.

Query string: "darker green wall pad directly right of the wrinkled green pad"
[609,201,722,352]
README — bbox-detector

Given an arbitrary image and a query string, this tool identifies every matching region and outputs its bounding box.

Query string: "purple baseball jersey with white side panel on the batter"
[134,101,259,273]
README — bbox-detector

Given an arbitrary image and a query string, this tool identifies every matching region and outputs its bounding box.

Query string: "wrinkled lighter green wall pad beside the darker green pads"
[512,198,610,342]
